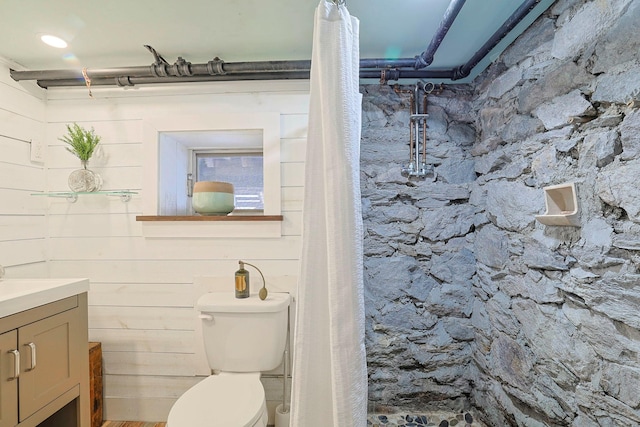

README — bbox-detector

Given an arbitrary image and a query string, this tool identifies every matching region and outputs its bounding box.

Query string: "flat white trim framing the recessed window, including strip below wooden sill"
[142,113,282,237]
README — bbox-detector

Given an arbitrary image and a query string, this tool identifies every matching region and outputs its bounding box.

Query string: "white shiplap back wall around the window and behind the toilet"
[42,81,309,421]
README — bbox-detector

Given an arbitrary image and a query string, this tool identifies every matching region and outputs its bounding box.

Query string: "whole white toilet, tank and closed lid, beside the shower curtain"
[167,292,290,427]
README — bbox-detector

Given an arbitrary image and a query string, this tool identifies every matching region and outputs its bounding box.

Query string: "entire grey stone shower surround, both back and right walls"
[361,0,640,427]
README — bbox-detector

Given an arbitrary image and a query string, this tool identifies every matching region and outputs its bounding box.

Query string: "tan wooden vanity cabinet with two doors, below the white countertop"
[0,294,90,427]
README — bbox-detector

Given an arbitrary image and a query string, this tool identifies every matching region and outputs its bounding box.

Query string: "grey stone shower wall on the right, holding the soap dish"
[469,0,640,427]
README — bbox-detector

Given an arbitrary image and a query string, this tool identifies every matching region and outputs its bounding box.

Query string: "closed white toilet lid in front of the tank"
[167,374,266,427]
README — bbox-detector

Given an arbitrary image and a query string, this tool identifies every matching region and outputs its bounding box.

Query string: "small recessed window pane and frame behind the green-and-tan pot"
[190,150,264,211]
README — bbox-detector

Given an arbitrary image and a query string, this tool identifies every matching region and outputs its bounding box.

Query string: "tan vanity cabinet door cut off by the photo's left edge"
[0,330,20,427]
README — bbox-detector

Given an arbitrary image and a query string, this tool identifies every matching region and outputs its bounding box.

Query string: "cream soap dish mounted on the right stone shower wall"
[536,182,580,227]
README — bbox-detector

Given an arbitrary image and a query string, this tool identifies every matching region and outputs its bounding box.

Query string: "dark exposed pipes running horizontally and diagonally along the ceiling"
[10,0,549,88]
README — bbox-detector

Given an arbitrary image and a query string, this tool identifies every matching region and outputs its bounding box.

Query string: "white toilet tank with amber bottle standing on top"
[196,292,290,372]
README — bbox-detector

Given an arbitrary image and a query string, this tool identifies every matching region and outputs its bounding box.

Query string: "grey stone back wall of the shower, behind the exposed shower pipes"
[361,85,478,413]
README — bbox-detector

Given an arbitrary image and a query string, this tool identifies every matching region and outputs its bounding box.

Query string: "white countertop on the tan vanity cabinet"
[0,279,89,317]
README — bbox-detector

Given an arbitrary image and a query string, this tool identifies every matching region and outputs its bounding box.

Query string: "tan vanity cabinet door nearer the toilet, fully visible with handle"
[18,309,86,421]
